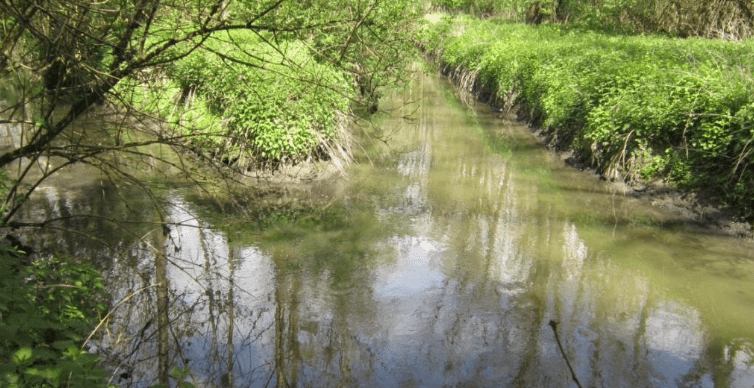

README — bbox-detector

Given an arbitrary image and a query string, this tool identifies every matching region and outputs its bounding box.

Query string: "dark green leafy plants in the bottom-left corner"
[0,246,108,387]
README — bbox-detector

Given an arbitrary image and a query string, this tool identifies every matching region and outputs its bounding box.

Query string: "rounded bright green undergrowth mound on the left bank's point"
[118,31,353,168]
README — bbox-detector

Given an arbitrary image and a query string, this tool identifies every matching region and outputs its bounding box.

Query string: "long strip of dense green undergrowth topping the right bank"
[423,16,754,216]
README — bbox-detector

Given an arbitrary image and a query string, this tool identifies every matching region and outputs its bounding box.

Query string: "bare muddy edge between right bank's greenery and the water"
[434,62,754,239]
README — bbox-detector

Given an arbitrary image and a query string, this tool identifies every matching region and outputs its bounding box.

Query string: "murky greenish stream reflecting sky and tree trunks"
[16,69,754,387]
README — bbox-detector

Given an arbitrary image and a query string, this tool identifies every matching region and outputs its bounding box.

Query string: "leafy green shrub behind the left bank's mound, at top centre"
[254,0,423,111]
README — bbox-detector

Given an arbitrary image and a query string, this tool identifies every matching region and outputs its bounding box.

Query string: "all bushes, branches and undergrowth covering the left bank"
[0,0,421,221]
